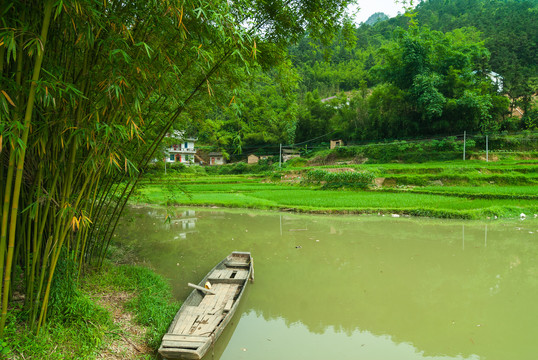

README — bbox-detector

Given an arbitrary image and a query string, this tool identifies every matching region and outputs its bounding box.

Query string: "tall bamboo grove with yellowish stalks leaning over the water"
[0,0,354,333]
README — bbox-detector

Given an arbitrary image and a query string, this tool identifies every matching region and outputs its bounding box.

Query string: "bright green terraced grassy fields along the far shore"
[132,160,538,219]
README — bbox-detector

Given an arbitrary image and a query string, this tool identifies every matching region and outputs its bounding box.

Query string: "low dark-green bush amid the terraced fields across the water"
[305,170,375,189]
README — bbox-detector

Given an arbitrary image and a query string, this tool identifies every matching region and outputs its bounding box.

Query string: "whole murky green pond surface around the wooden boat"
[116,208,538,360]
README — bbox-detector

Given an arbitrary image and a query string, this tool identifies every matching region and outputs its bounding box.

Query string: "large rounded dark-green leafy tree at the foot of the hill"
[373,25,498,136]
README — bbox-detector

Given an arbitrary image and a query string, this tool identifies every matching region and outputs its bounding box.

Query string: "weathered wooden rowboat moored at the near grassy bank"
[159,251,254,359]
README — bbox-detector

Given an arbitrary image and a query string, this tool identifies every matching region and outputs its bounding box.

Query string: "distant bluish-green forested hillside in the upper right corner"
[418,0,538,97]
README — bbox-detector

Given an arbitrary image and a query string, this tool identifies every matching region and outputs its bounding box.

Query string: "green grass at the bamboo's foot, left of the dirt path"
[0,256,113,360]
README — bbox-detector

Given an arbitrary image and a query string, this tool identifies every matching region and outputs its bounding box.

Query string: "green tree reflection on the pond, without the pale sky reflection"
[116,210,538,358]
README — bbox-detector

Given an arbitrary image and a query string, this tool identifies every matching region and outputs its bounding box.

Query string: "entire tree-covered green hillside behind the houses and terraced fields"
[191,0,538,150]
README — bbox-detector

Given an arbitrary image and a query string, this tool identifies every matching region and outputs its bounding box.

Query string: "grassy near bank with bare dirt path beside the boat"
[0,264,179,359]
